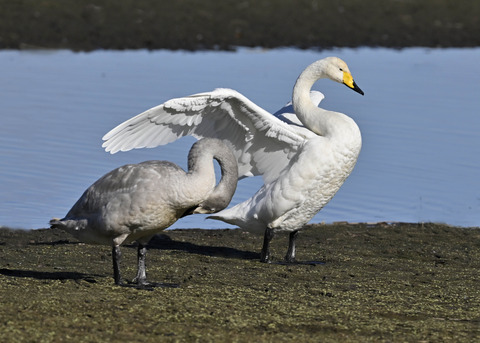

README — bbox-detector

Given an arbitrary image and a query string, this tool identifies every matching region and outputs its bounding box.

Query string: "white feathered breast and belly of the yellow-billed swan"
[269,131,361,230]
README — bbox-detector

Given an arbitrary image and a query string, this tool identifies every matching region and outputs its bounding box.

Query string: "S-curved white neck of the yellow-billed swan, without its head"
[292,60,346,137]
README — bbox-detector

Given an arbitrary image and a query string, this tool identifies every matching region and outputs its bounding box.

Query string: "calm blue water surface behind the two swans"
[0,48,480,229]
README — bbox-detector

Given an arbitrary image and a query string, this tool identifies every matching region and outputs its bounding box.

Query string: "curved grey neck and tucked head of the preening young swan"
[188,139,238,213]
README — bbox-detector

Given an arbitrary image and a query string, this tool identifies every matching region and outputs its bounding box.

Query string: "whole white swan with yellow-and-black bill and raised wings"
[103,57,363,262]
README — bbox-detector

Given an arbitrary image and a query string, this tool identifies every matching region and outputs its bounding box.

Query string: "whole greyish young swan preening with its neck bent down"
[50,139,238,285]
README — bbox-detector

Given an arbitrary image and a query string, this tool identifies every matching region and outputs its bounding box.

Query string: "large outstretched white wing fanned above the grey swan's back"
[103,89,304,182]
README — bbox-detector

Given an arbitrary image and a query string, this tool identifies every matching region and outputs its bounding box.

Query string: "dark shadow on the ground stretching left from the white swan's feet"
[148,234,260,260]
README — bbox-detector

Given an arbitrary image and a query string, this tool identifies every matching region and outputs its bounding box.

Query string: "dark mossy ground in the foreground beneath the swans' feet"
[0,224,480,342]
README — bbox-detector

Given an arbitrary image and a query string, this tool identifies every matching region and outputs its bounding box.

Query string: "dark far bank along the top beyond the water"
[0,0,480,50]
